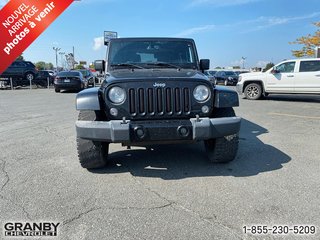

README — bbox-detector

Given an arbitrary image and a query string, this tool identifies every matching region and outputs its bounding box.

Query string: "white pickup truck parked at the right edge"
[237,58,320,100]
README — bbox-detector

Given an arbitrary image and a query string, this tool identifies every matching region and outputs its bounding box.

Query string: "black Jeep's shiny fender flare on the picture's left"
[76,87,101,111]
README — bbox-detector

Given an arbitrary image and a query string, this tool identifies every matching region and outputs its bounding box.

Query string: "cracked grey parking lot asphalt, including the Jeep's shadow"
[0,89,320,239]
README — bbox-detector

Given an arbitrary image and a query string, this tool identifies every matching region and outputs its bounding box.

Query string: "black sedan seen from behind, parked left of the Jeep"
[54,71,88,92]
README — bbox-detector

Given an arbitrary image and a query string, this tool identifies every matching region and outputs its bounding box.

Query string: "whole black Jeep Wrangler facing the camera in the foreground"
[76,38,241,168]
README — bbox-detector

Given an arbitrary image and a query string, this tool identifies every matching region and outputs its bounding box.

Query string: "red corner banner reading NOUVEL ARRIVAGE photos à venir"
[0,0,74,74]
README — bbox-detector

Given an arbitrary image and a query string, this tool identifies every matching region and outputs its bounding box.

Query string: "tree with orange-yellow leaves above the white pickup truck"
[290,22,320,58]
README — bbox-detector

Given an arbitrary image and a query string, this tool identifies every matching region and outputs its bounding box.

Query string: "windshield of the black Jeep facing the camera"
[109,40,197,68]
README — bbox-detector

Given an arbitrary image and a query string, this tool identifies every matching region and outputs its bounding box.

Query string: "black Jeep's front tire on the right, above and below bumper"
[204,108,239,163]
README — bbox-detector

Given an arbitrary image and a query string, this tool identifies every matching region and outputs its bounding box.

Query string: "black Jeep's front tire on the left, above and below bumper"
[77,111,109,169]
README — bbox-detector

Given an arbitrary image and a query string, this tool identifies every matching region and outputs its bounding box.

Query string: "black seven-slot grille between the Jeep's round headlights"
[128,87,191,116]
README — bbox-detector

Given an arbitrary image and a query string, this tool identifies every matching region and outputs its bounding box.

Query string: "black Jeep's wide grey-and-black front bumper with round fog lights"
[76,117,241,143]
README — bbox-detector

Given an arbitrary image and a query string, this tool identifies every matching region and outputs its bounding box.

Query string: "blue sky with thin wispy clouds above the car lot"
[0,0,320,68]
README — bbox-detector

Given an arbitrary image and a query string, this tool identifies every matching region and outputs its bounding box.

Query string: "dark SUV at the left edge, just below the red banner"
[0,61,38,86]
